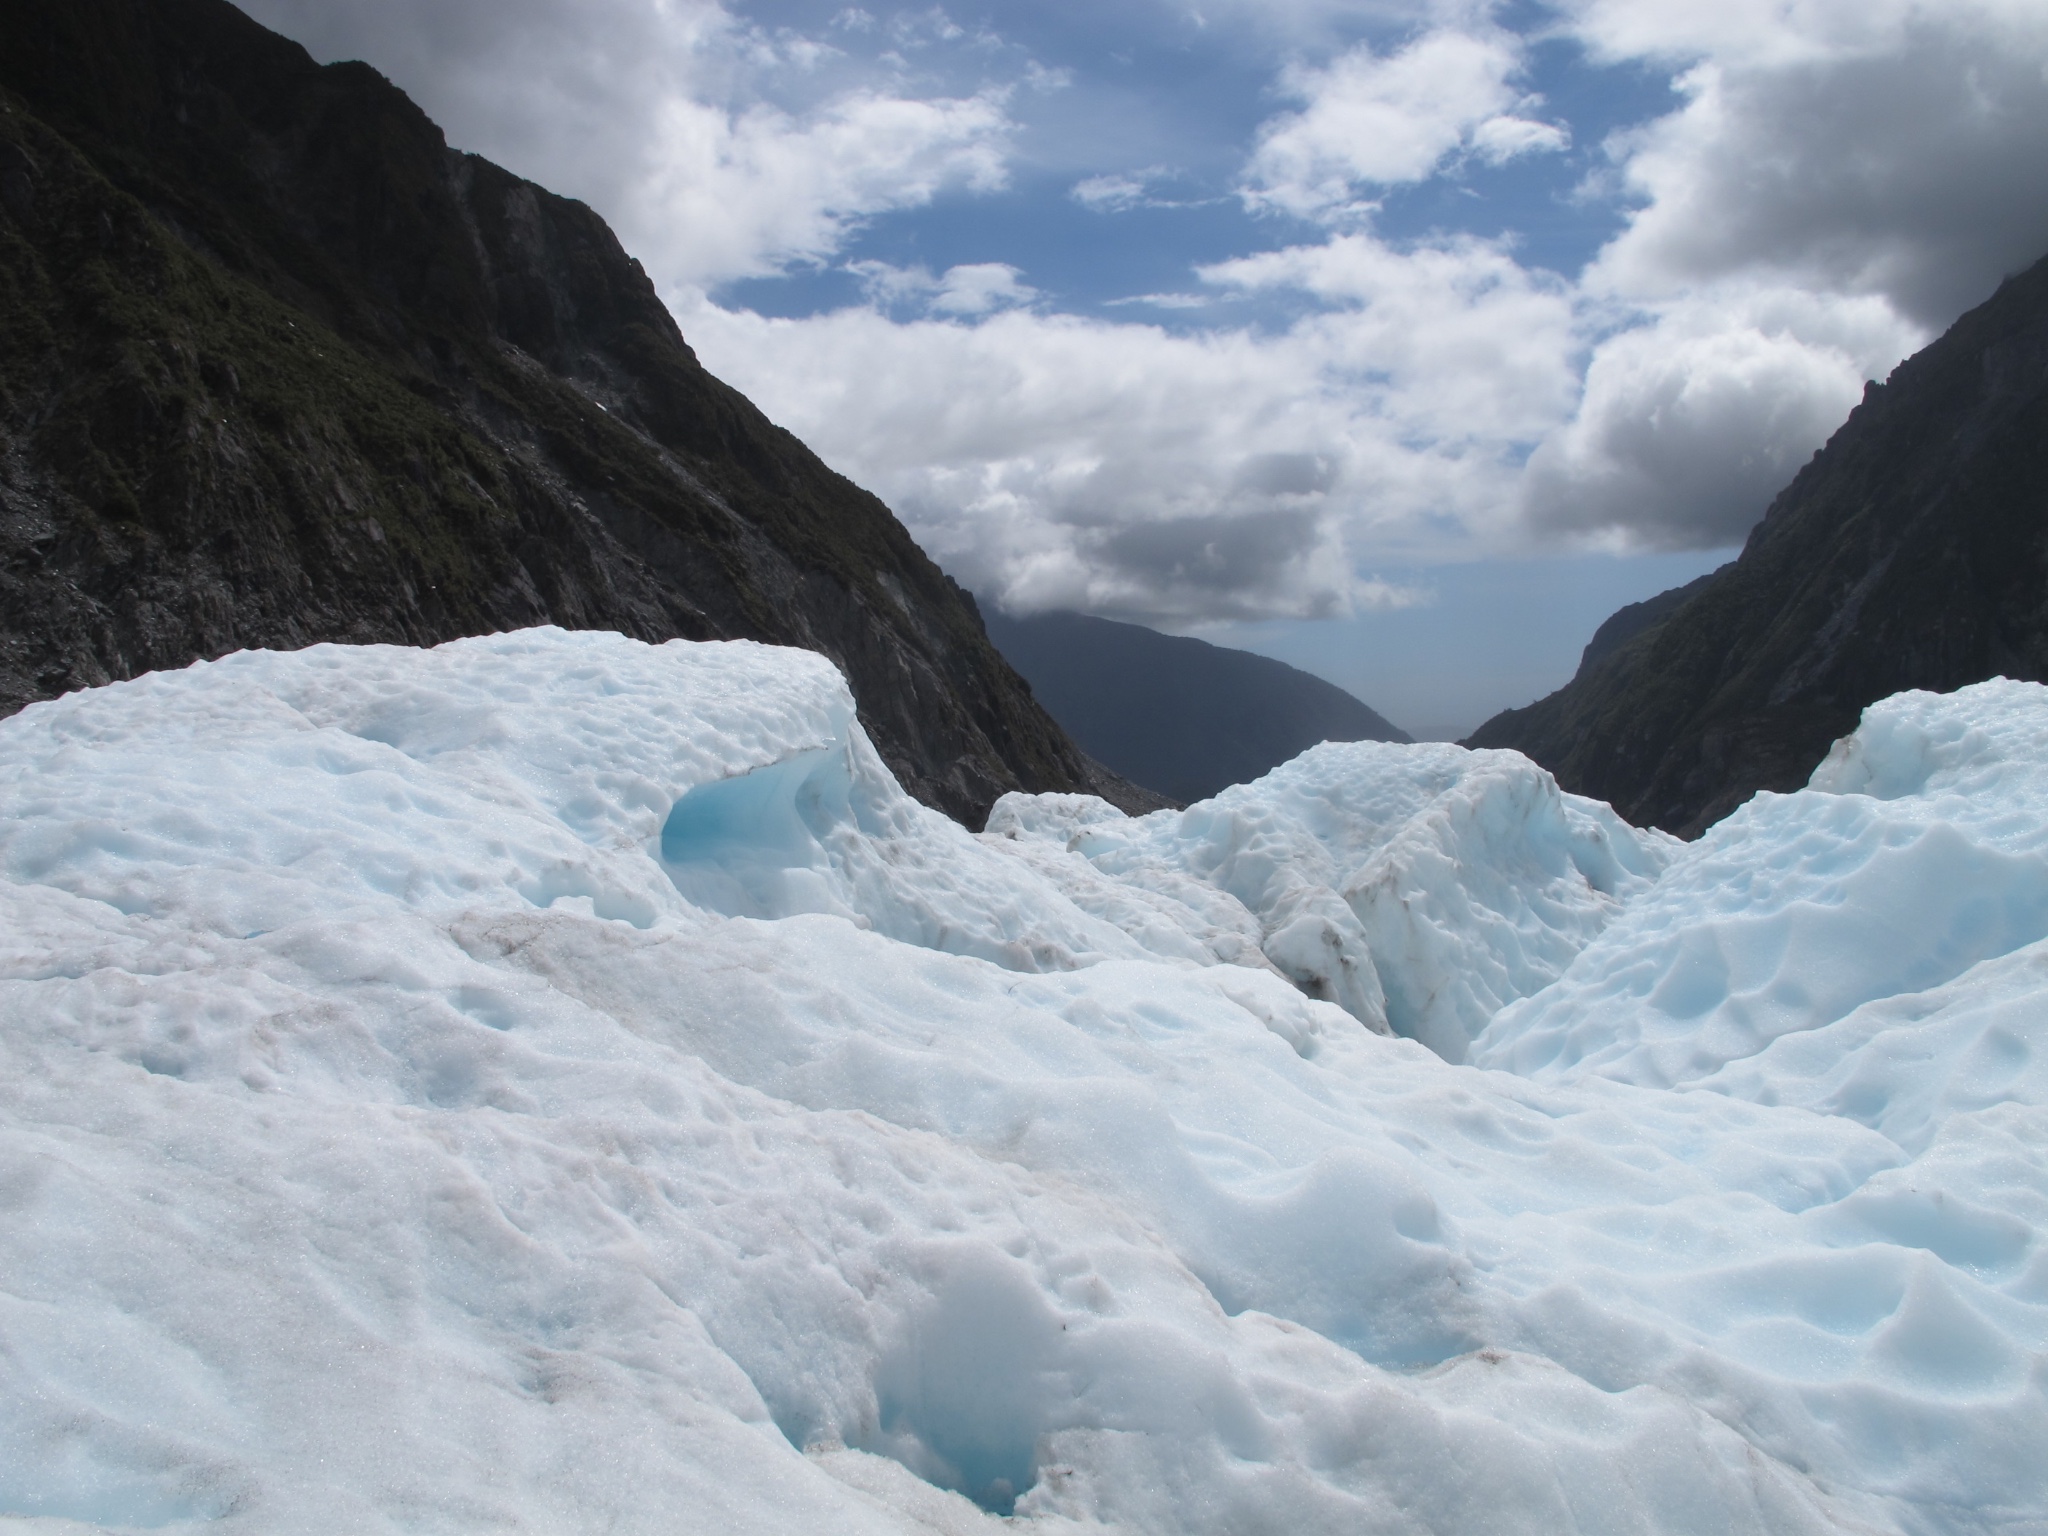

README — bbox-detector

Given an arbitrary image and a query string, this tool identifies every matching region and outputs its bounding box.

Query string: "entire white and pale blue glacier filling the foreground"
[0,629,2048,1536]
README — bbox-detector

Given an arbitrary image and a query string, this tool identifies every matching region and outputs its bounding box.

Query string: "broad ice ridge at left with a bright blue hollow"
[0,629,1187,971]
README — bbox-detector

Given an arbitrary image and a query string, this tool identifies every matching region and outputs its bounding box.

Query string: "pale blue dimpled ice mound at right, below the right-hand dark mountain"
[1475,678,2048,1087]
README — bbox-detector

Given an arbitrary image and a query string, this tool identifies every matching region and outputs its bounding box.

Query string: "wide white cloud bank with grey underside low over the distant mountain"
[684,233,1575,623]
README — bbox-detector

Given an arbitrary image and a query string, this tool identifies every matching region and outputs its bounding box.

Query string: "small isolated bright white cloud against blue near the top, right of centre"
[1245,29,1569,219]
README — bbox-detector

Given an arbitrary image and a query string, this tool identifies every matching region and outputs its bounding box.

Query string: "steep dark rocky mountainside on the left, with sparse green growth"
[0,0,1116,825]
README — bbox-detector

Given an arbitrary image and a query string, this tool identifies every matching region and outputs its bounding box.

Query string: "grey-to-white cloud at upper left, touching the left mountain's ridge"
[248,0,1014,289]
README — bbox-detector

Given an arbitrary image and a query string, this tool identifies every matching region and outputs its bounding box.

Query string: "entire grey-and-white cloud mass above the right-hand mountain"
[1522,0,2048,549]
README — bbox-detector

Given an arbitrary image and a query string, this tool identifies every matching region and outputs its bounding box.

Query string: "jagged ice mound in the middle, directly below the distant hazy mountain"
[989,741,1679,1061]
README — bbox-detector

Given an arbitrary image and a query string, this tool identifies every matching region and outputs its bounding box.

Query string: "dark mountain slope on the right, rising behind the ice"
[1466,249,2048,836]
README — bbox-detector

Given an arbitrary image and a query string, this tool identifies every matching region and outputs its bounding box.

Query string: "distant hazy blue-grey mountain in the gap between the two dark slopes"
[983,604,1409,805]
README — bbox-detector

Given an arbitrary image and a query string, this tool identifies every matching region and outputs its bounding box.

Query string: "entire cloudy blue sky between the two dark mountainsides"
[244,0,2048,737]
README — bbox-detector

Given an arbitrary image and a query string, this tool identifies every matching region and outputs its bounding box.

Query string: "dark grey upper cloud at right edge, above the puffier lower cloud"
[1593,12,2048,328]
